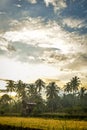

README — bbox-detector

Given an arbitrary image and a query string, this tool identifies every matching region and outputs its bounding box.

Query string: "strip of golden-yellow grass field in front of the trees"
[0,117,87,130]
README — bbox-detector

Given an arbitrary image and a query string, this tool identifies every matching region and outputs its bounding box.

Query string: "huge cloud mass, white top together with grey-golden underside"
[1,17,87,83]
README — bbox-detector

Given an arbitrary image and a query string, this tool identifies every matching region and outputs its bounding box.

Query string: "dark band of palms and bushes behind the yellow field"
[0,76,87,118]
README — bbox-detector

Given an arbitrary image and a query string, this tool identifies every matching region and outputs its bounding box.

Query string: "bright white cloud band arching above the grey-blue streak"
[2,17,87,53]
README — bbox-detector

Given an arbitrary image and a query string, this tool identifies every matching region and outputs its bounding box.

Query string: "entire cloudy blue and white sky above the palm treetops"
[0,0,87,88]
